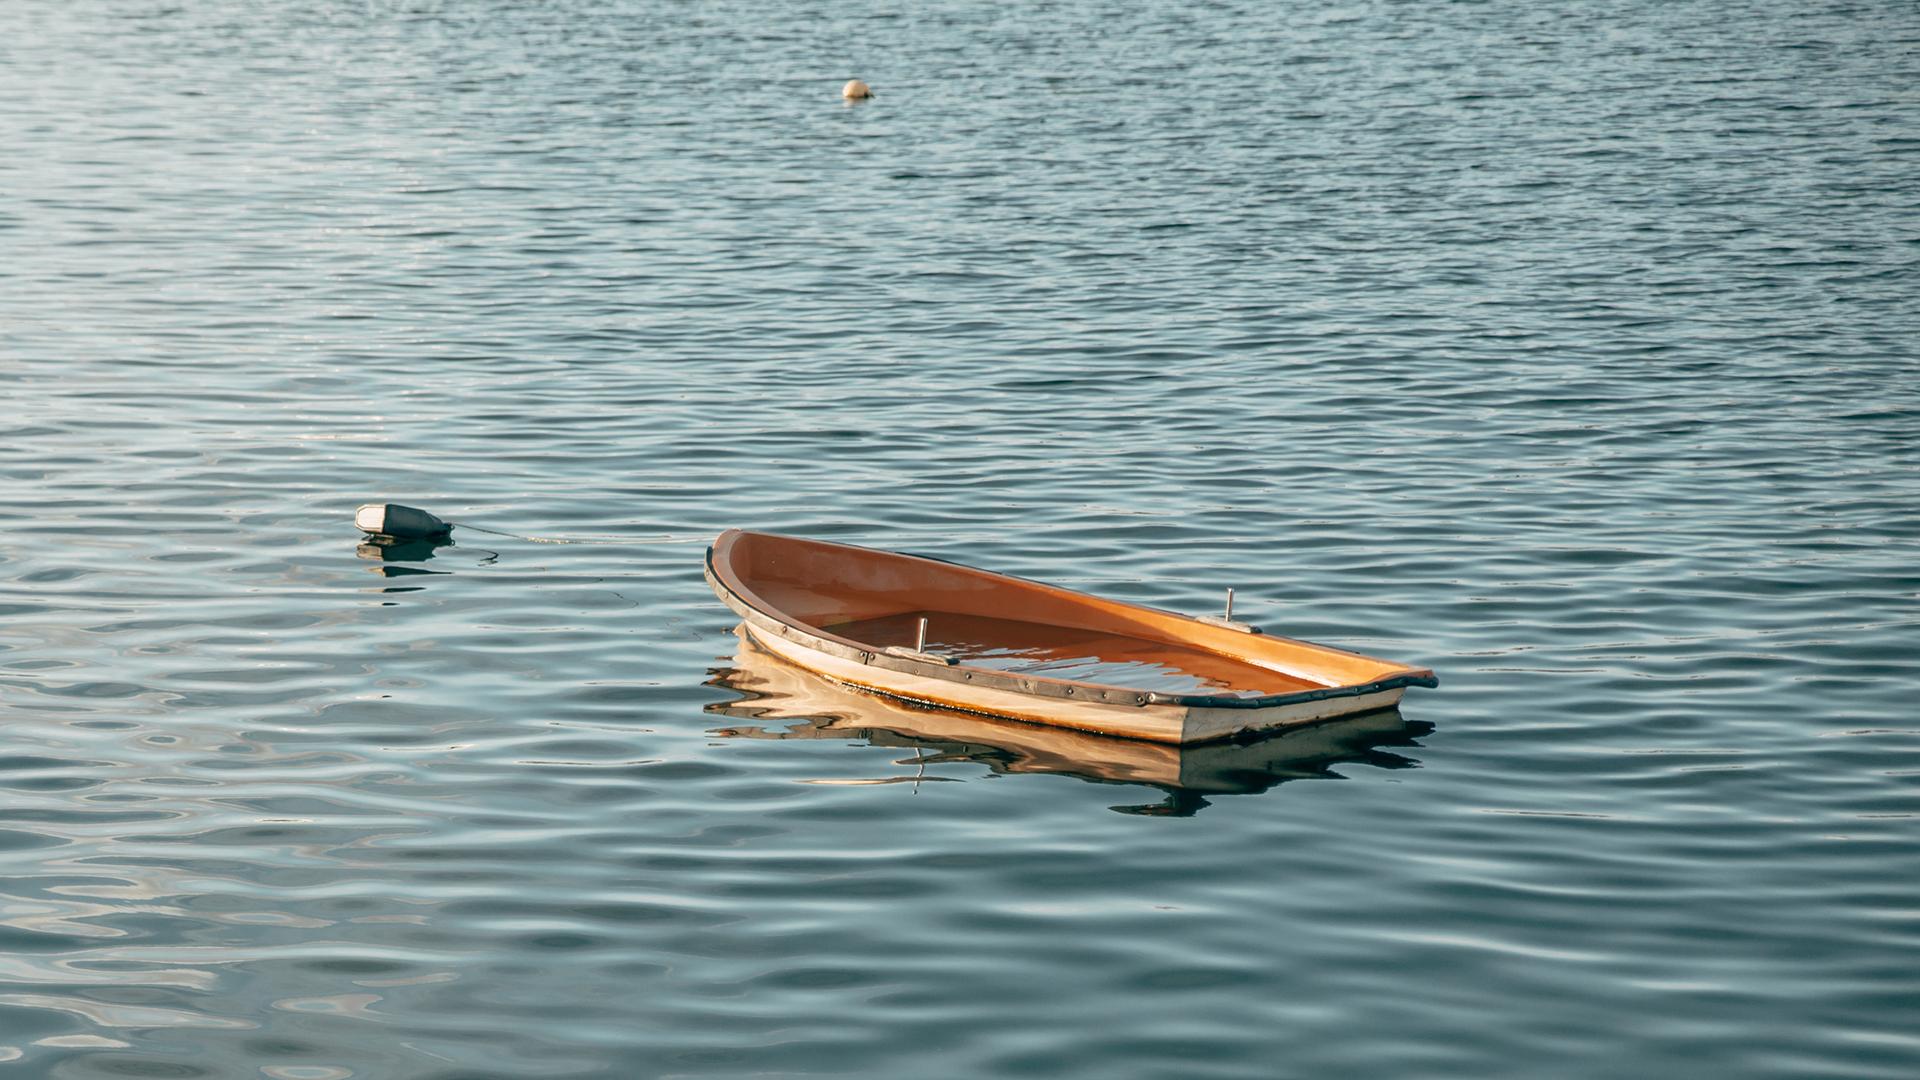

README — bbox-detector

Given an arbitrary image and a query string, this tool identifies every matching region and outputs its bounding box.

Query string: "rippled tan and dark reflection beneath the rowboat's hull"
[707,626,1432,813]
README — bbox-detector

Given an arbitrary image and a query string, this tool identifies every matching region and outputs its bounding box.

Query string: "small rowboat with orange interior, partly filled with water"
[707,528,1436,744]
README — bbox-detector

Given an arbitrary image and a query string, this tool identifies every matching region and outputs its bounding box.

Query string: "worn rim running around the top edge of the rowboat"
[707,528,1440,709]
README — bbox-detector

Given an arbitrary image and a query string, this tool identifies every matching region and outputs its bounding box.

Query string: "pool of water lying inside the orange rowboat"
[820,611,1325,698]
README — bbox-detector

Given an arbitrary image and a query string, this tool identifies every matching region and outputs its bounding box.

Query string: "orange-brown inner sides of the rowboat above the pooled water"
[712,530,1413,692]
